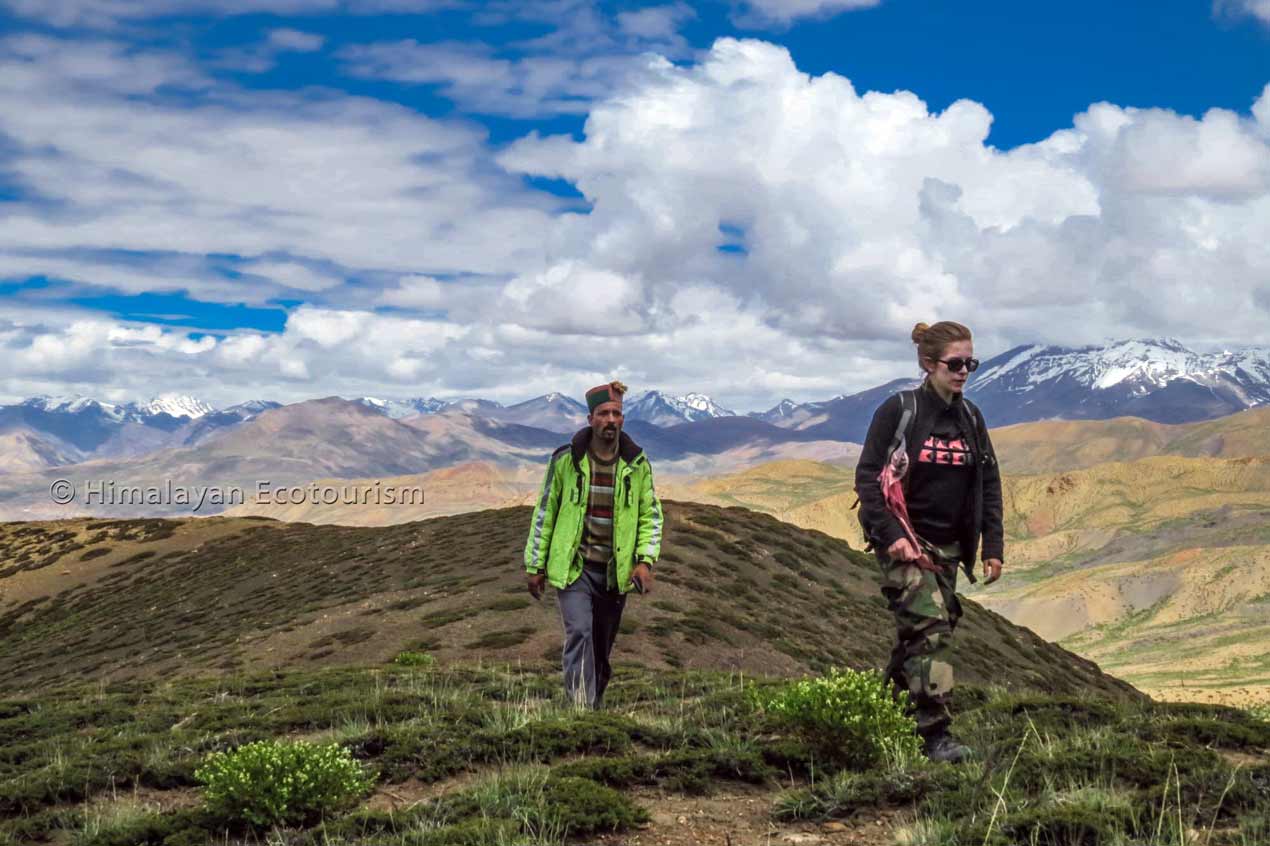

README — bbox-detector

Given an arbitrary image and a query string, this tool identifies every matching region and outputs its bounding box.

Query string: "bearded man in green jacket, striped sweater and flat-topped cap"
[525,381,664,708]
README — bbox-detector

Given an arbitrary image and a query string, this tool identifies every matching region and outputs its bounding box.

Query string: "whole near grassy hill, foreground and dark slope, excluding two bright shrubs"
[0,502,1270,846]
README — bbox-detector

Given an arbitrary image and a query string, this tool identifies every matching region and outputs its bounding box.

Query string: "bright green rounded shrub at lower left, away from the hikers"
[194,741,373,826]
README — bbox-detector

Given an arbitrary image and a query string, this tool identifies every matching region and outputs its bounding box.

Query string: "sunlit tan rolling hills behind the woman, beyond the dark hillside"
[660,447,1270,704]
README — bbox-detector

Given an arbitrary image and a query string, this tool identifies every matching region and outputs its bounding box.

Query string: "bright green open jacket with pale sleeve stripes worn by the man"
[525,428,665,593]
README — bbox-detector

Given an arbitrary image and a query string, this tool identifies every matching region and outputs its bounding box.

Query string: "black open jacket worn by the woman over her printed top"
[856,385,1005,567]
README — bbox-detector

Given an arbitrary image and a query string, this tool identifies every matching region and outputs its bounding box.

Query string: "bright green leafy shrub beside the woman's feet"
[765,669,921,769]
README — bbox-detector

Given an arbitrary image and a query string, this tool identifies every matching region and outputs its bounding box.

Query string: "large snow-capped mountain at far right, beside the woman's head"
[966,339,1270,426]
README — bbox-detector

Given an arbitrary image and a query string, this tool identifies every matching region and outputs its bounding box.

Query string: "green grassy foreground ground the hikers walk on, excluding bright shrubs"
[0,663,1270,846]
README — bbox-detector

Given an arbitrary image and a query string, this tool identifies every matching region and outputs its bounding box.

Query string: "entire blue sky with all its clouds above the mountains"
[0,0,1270,408]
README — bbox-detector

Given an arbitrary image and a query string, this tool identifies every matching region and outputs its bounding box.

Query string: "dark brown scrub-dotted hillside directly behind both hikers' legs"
[0,502,1137,696]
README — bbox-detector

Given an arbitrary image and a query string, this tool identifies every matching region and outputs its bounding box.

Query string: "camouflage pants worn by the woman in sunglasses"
[878,544,961,737]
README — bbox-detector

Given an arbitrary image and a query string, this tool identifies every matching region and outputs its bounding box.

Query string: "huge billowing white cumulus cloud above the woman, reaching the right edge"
[502,39,1270,359]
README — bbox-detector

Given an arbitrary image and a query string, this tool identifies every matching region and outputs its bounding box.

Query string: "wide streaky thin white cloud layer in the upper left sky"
[0,37,556,297]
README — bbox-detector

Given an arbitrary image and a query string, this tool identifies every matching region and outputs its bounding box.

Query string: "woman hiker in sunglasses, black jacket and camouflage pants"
[856,320,1003,762]
